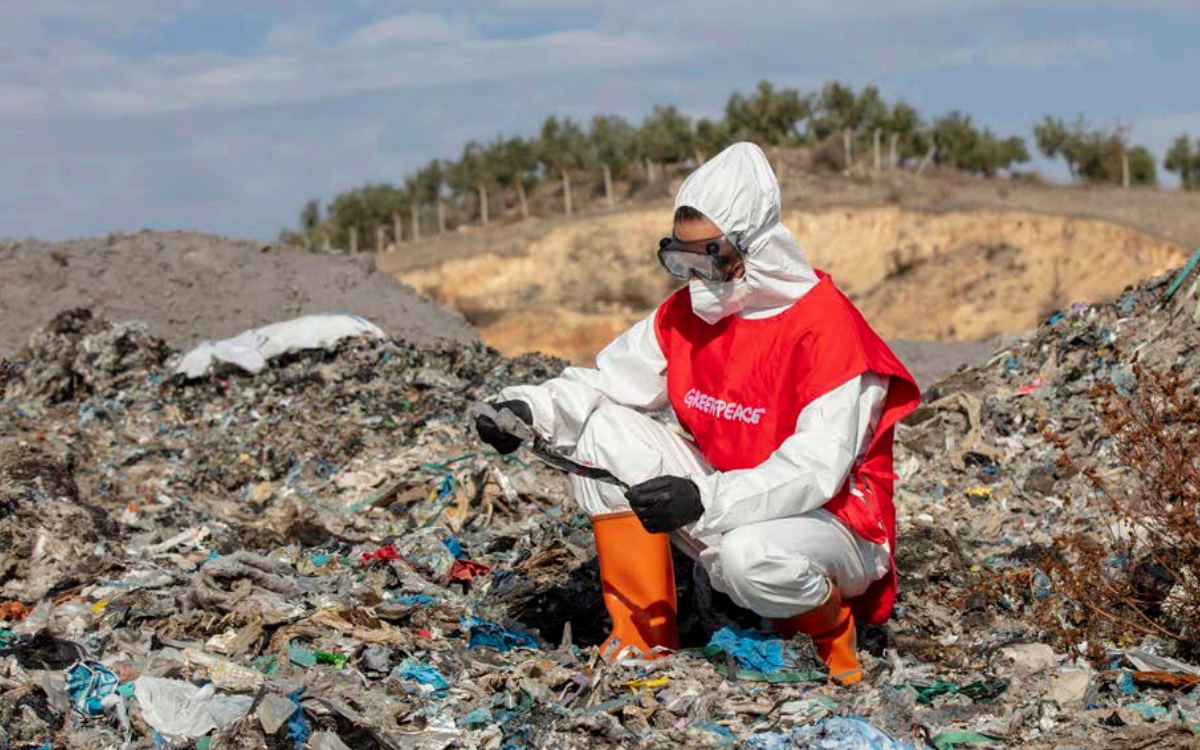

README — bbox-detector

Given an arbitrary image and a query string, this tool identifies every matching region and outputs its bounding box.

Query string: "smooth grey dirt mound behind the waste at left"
[0,232,478,353]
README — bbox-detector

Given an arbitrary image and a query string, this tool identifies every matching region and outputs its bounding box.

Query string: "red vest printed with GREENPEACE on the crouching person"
[655,271,920,624]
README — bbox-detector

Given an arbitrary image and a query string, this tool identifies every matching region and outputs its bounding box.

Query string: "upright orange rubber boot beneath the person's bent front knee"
[592,510,679,659]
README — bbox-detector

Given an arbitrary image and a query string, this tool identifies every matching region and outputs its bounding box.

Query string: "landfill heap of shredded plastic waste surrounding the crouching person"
[0,260,1200,750]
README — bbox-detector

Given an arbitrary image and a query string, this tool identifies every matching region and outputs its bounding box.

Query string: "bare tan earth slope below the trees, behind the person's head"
[391,205,1183,382]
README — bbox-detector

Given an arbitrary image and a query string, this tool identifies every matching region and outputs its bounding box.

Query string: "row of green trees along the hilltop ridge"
[281,82,1171,250]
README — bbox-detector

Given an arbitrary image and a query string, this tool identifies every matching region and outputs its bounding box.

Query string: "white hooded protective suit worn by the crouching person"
[502,144,890,618]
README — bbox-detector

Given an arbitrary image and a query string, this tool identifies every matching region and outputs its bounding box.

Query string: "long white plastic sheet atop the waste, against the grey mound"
[175,314,385,378]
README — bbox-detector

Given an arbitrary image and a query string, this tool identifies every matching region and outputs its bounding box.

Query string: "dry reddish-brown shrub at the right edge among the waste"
[988,367,1200,662]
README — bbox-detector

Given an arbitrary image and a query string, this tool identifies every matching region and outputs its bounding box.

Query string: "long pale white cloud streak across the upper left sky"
[0,13,695,116]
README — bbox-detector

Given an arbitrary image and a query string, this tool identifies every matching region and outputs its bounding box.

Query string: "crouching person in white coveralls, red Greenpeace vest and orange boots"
[476,143,919,684]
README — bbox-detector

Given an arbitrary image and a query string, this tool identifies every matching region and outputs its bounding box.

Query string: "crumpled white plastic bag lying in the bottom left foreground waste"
[133,677,254,739]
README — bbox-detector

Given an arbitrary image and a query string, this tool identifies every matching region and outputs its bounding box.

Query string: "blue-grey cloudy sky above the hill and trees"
[0,0,1200,240]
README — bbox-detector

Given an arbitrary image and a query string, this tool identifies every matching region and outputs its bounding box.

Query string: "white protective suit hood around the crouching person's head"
[676,143,817,323]
